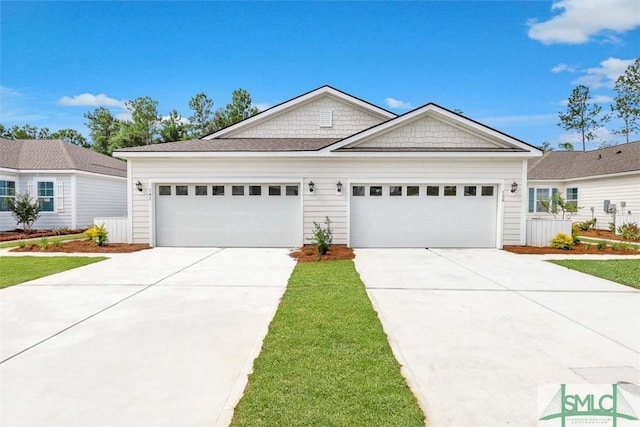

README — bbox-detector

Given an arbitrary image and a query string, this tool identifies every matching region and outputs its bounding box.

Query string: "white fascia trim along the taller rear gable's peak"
[202,86,397,140]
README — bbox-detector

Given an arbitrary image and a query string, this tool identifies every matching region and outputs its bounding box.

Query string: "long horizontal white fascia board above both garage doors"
[112,151,538,159]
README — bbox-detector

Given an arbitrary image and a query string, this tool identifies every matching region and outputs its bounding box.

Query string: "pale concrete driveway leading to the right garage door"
[355,249,640,427]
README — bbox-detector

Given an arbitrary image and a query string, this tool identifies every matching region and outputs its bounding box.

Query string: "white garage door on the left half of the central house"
[155,183,302,247]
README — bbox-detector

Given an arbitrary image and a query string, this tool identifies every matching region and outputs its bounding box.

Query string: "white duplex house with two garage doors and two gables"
[114,86,541,248]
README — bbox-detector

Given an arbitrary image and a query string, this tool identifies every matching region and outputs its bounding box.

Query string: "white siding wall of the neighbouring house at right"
[527,174,640,230]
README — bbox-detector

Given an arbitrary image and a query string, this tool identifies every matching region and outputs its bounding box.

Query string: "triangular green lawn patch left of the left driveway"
[0,256,107,289]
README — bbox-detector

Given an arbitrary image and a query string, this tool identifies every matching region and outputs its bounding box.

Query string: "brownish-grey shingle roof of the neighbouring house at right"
[528,141,640,180]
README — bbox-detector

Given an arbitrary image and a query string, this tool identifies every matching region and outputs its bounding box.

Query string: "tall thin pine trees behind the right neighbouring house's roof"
[540,58,640,151]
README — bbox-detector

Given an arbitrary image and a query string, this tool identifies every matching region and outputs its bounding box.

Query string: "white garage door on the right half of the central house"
[350,184,497,248]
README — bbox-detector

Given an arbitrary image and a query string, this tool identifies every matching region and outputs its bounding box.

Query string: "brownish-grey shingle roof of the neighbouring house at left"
[0,138,127,177]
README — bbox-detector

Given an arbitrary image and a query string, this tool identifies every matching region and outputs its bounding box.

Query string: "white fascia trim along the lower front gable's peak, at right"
[322,104,542,157]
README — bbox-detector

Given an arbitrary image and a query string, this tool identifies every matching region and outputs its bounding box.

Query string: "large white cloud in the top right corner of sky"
[528,0,640,44]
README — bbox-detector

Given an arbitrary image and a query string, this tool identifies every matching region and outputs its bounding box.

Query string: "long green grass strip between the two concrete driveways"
[231,261,425,426]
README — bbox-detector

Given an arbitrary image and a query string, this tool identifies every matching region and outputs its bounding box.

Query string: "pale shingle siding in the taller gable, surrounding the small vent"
[225,95,388,138]
